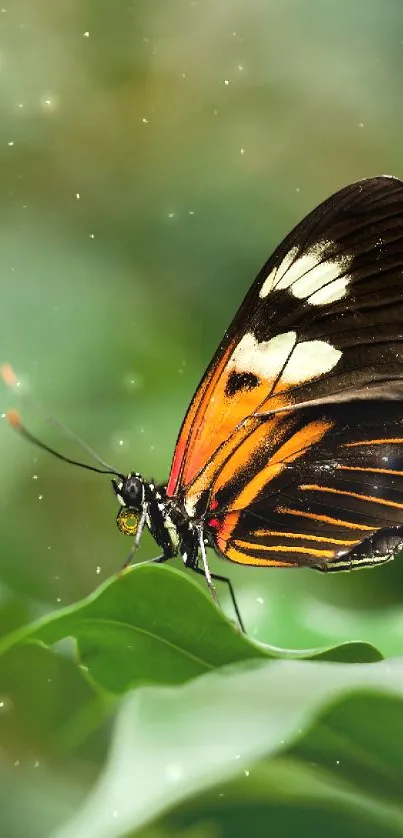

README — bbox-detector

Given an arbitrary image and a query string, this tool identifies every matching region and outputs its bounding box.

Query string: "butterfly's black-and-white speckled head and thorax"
[112,472,199,566]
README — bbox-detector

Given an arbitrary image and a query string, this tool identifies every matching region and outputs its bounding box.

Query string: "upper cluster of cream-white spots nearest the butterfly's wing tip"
[259,241,352,305]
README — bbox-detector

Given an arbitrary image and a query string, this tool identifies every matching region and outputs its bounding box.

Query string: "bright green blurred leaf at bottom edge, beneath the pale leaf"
[149,756,403,838]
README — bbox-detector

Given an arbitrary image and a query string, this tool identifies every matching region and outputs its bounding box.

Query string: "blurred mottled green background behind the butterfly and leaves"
[0,0,403,838]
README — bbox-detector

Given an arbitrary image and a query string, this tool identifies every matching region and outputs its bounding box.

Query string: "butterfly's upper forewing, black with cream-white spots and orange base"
[167,177,403,502]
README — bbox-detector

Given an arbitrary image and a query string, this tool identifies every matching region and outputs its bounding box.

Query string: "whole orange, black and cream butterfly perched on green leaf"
[4,176,403,626]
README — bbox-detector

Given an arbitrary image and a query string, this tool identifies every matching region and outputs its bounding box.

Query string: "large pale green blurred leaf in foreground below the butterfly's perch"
[53,659,403,838]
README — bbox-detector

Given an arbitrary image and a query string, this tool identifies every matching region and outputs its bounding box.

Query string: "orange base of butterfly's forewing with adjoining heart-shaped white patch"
[167,331,341,497]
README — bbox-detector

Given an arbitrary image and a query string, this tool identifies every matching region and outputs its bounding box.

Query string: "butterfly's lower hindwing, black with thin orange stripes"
[207,401,403,570]
